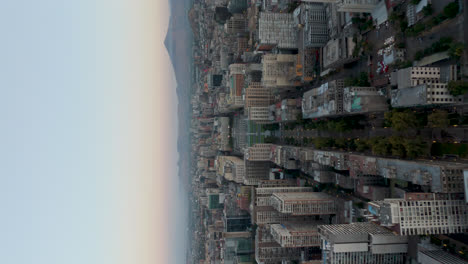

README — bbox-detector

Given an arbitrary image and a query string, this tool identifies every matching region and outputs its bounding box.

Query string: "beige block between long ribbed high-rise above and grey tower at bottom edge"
[270,222,323,247]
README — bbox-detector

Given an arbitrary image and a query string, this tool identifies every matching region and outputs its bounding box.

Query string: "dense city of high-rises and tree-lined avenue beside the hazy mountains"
[179,0,468,264]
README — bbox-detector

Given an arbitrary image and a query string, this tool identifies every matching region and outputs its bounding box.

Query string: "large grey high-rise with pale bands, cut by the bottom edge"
[318,223,408,264]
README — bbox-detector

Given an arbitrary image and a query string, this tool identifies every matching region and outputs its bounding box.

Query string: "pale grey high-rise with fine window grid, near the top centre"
[258,12,297,49]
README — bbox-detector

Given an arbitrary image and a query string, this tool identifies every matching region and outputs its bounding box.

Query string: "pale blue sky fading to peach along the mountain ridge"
[0,0,181,264]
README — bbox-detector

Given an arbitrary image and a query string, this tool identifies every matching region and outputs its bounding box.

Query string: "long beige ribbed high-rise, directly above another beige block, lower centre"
[270,192,336,215]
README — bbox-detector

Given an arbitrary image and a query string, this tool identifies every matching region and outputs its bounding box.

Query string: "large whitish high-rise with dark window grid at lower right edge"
[370,193,468,235]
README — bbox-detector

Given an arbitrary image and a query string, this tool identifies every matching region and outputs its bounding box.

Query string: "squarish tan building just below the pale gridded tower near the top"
[262,54,297,88]
